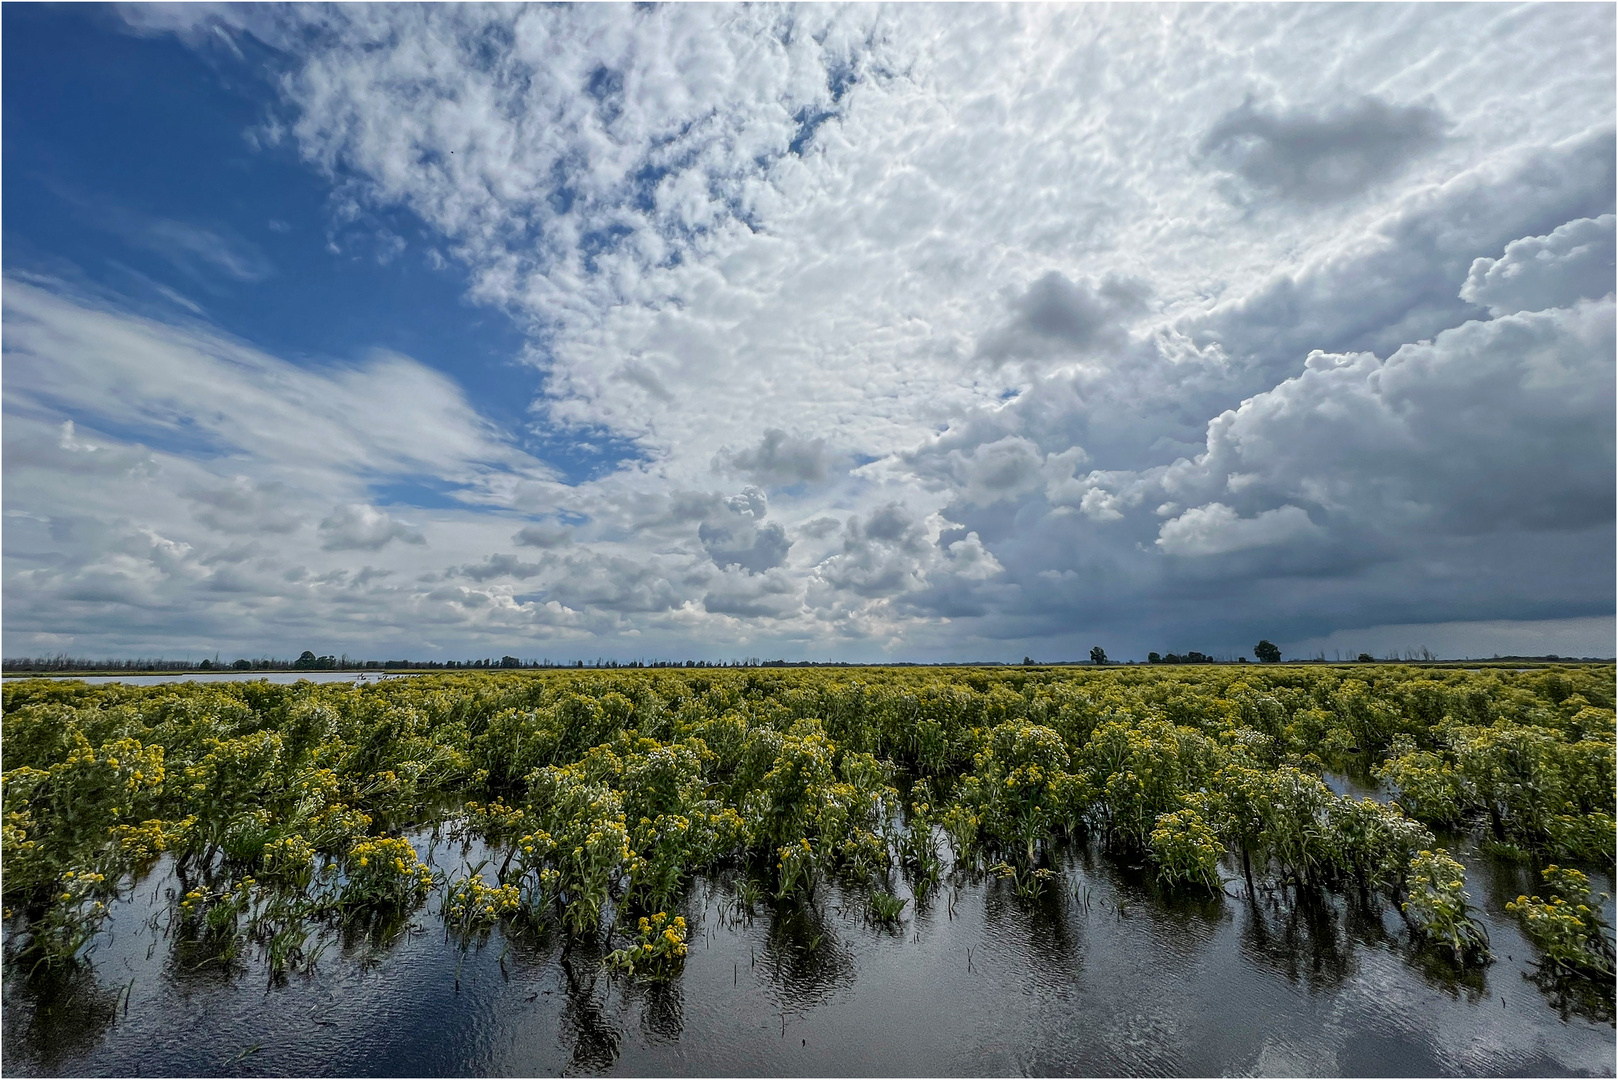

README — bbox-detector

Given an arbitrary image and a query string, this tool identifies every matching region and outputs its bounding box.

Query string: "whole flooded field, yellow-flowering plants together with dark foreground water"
[0,667,1618,1075]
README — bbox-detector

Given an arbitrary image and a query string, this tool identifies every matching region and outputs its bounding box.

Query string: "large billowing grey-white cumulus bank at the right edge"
[1084,298,1615,554]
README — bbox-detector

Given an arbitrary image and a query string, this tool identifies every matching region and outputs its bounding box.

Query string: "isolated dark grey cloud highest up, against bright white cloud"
[1197,97,1448,202]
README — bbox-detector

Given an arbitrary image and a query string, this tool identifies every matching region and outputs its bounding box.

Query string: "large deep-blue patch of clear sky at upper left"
[0,5,537,456]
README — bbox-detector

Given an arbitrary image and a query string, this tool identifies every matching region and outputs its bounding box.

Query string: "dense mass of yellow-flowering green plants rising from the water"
[0,665,1615,997]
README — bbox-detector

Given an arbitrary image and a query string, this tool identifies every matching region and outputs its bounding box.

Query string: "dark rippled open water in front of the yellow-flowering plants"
[0,834,1615,1075]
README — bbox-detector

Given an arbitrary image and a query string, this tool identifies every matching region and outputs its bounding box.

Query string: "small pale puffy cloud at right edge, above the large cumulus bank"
[1461,214,1618,316]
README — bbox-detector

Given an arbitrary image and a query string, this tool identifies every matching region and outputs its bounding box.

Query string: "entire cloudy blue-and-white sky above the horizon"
[0,3,1618,662]
